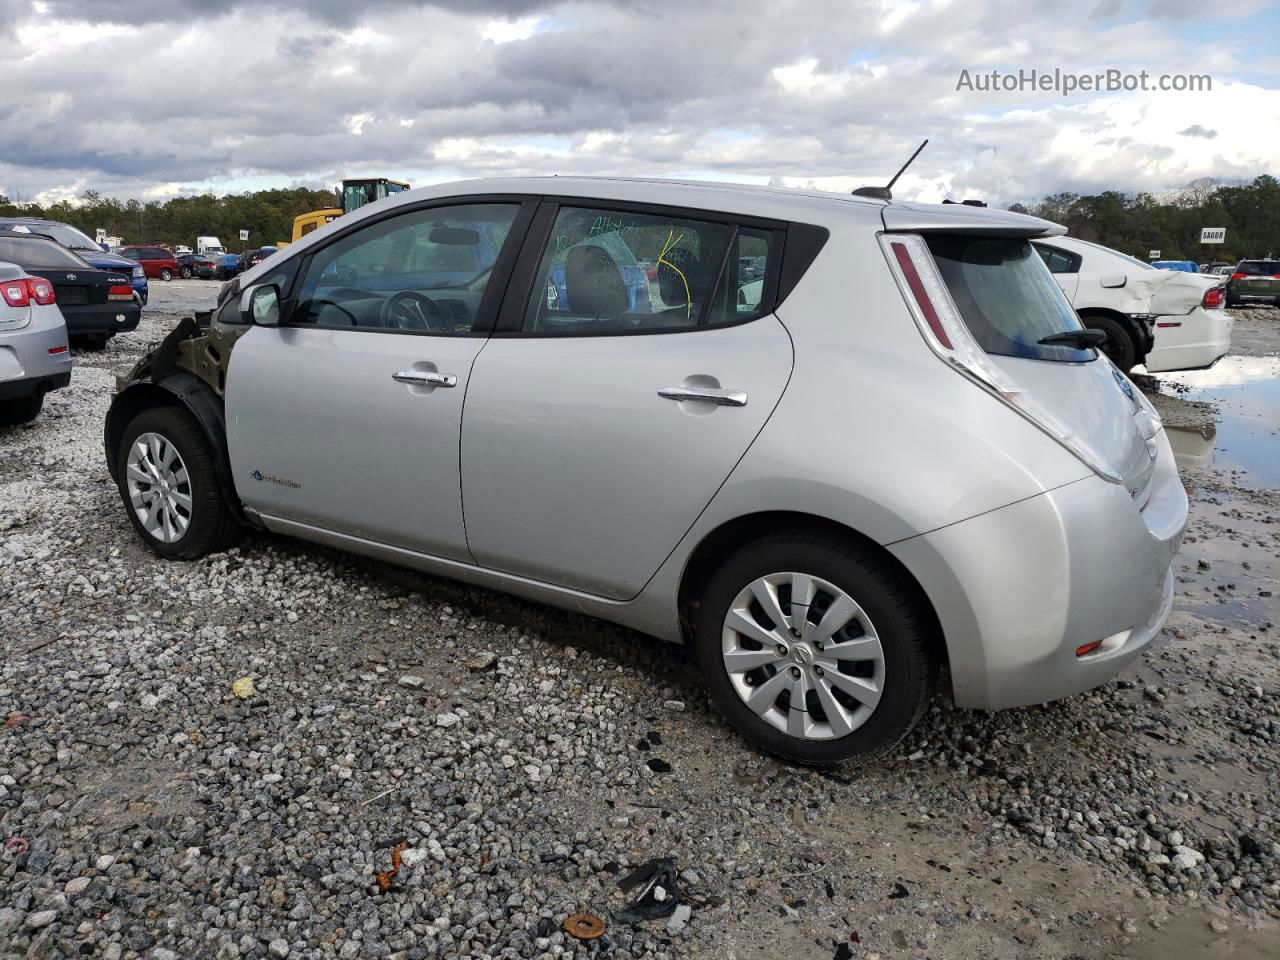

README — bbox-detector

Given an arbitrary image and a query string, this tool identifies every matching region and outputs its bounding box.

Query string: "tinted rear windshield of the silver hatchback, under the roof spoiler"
[925,234,1096,364]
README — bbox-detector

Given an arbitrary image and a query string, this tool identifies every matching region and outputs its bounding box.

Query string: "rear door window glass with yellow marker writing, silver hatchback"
[521,207,773,335]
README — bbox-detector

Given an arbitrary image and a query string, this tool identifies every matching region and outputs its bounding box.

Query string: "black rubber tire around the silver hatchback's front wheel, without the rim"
[115,407,244,559]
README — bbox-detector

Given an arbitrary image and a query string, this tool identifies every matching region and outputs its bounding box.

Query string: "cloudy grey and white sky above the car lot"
[0,0,1280,202]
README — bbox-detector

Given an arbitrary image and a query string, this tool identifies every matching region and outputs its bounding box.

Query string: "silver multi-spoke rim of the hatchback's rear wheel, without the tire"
[721,572,884,740]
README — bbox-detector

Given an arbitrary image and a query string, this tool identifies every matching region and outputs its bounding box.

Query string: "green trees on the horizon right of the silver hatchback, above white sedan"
[1010,174,1280,264]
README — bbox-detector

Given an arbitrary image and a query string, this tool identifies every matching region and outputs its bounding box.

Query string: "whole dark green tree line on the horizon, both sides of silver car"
[0,174,1280,262]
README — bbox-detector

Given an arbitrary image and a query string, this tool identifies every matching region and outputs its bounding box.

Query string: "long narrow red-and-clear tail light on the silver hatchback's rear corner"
[879,234,1140,484]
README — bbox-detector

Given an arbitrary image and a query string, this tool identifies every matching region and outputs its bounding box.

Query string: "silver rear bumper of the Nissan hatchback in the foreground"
[890,434,1188,709]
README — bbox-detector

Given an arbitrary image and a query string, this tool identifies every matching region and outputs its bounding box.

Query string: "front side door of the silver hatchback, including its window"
[227,202,526,561]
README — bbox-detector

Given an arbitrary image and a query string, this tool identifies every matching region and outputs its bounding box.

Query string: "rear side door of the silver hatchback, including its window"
[462,201,791,599]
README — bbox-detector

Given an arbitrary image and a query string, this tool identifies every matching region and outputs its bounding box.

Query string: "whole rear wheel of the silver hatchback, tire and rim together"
[694,532,933,765]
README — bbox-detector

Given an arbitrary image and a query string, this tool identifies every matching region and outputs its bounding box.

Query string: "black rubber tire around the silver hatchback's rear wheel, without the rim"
[694,531,934,767]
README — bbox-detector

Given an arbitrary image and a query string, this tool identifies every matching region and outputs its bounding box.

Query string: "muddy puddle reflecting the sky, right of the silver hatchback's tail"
[1144,356,1280,489]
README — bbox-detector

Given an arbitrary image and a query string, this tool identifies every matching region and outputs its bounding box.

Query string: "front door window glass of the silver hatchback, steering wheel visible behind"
[289,204,520,334]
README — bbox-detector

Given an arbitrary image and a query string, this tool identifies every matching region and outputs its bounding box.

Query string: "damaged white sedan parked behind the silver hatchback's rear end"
[1034,237,1234,374]
